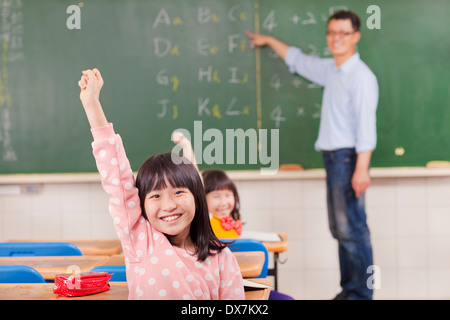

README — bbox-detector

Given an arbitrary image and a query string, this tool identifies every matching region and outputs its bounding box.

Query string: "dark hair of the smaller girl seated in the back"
[202,169,241,220]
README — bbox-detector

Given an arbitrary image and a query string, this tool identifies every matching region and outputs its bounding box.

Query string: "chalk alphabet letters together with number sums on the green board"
[150,2,345,128]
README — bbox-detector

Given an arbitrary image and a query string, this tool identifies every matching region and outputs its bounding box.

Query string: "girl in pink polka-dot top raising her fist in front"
[78,69,245,300]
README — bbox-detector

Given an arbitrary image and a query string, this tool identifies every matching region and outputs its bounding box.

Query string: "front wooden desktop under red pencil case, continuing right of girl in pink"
[0,279,270,300]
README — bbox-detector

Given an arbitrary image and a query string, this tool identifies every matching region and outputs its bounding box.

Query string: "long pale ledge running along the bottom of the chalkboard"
[0,167,450,185]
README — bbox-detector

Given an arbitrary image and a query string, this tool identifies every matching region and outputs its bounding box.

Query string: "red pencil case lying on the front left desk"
[53,272,111,297]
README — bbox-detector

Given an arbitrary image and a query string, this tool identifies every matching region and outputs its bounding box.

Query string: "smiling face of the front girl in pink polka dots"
[144,180,195,246]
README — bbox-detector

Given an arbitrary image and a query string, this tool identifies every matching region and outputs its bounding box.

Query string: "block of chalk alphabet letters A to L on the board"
[150,2,254,121]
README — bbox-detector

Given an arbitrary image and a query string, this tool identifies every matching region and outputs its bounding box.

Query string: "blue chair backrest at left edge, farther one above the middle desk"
[0,242,82,257]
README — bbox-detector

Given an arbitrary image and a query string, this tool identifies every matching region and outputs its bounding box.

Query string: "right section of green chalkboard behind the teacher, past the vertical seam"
[259,0,450,168]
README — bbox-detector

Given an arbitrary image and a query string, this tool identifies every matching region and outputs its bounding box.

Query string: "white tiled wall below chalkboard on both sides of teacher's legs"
[238,178,450,299]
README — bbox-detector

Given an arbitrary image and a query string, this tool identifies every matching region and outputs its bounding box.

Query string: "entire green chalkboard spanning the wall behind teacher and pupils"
[0,0,450,174]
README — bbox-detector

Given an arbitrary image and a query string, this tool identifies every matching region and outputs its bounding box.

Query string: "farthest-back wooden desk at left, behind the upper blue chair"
[8,239,122,256]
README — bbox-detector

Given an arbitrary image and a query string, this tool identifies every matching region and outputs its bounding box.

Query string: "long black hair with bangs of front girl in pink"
[136,153,226,261]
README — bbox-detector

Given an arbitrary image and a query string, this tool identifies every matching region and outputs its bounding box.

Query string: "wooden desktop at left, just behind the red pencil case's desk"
[0,256,109,280]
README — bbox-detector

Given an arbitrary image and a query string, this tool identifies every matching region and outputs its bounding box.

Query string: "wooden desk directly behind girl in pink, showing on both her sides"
[102,251,264,278]
